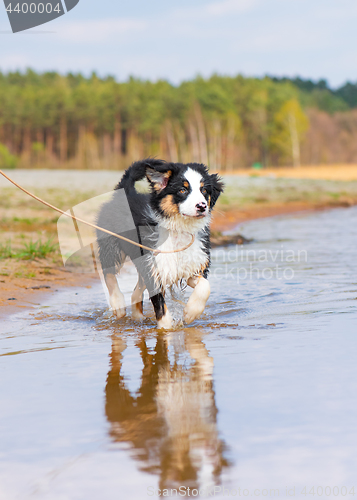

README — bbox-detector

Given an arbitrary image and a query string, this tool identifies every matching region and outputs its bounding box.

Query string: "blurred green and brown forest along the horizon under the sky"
[0,70,357,172]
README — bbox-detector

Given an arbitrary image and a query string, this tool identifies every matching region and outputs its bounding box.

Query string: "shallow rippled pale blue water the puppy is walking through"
[0,208,357,500]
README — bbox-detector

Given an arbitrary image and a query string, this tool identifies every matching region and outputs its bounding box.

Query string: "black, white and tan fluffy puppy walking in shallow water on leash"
[97,158,223,329]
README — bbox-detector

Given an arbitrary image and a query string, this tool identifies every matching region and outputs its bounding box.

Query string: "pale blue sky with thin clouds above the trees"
[0,0,357,86]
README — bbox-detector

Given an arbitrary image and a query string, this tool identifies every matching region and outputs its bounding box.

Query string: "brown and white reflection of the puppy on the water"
[106,328,228,489]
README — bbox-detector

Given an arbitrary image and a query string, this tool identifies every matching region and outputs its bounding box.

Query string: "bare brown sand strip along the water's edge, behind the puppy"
[0,202,353,318]
